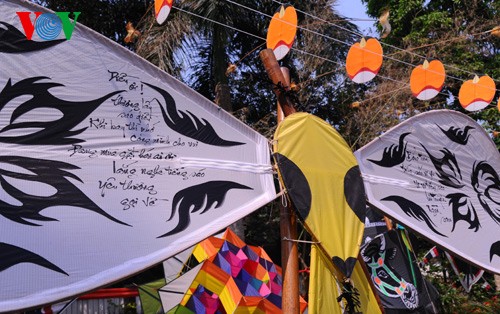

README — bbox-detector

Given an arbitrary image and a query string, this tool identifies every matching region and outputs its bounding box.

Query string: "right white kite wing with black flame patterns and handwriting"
[355,110,500,273]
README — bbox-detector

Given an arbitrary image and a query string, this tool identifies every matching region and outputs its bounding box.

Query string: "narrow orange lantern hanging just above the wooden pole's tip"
[266,5,297,60]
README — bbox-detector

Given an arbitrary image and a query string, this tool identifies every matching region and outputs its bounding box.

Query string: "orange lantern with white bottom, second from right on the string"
[410,60,446,100]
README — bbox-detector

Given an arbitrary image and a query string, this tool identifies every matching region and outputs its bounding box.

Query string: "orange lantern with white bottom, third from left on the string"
[346,38,383,83]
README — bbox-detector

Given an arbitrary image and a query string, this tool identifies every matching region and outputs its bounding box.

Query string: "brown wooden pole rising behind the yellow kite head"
[260,49,300,314]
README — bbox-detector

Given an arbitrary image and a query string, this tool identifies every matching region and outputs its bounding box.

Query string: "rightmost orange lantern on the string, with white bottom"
[458,75,496,111]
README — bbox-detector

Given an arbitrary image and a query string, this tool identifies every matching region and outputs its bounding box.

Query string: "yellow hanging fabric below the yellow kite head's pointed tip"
[308,245,382,314]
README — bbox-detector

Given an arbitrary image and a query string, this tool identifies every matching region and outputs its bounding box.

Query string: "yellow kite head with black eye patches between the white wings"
[274,113,366,277]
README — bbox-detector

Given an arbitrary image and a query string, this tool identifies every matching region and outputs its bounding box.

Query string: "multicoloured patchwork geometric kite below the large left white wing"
[160,229,307,313]
